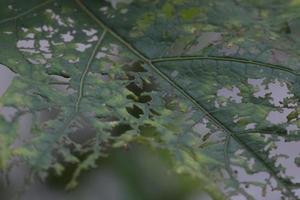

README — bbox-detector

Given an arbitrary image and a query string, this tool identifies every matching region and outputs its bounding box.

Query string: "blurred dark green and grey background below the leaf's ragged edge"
[0,145,210,200]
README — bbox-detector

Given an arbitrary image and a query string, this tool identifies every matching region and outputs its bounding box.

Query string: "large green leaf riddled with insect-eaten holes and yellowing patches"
[0,0,300,199]
